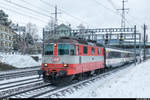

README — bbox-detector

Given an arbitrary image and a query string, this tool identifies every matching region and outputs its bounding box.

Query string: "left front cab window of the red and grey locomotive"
[44,44,54,55]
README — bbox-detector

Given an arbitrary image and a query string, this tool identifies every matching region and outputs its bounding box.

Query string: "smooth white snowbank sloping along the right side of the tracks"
[63,60,150,98]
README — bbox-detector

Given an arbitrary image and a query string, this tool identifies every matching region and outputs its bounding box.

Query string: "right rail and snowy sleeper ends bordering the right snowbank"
[39,66,132,98]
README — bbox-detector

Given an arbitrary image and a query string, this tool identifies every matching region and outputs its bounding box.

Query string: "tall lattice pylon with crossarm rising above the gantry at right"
[118,0,129,28]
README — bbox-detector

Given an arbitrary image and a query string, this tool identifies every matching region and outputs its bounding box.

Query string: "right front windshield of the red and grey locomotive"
[58,44,75,55]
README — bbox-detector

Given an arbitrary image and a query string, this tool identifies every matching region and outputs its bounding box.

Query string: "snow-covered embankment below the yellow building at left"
[0,54,41,68]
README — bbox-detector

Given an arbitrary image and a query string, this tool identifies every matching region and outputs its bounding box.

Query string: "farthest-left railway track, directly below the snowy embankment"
[0,67,40,81]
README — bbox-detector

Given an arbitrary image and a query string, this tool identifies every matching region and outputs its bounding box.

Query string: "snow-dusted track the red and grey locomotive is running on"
[3,63,132,98]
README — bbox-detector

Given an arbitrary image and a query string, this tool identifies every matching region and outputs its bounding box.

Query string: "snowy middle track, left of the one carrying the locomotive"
[0,75,46,98]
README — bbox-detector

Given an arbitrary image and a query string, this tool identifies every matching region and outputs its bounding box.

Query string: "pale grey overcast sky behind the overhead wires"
[0,0,150,39]
